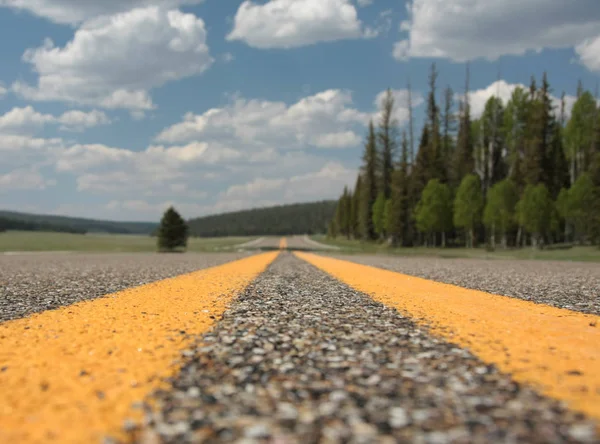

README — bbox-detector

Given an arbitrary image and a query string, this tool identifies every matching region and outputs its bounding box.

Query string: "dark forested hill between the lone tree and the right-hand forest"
[188,201,336,237]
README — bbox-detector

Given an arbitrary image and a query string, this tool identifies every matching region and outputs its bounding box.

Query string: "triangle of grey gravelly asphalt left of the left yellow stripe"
[0,253,250,322]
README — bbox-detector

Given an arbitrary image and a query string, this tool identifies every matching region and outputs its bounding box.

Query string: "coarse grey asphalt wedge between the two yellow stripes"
[137,253,599,444]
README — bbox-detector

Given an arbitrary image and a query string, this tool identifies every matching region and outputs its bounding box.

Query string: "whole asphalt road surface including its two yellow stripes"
[0,245,600,443]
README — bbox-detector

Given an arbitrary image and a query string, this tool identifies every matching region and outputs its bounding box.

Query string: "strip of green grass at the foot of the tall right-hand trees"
[311,236,600,262]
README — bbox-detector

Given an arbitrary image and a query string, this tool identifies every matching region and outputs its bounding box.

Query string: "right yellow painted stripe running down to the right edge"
[295,253,600,419]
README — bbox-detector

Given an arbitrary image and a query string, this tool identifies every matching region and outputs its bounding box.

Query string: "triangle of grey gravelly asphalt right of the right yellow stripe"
[327,253,600,315]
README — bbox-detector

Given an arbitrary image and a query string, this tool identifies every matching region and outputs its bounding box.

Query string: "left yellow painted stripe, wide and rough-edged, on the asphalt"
[0,252,278,443]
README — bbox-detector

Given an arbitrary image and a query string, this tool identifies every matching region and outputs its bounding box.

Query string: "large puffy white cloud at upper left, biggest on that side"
[13,7,213,110]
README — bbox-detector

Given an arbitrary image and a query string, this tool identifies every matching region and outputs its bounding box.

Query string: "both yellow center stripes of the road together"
[0,248,600,443]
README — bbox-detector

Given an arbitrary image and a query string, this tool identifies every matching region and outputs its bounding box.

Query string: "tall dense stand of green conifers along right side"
[328,64,600,249]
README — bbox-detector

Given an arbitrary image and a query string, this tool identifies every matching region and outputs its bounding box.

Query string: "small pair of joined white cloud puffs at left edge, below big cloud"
[0,106,110,134]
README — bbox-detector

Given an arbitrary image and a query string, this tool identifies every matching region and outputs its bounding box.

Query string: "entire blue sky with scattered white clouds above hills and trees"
[0,0,600,220]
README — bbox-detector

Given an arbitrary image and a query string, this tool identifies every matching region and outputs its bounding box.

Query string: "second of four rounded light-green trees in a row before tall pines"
[454,174,483,248]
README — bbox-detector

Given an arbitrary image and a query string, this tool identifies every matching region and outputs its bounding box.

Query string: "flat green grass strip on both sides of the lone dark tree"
[0,231,255,253]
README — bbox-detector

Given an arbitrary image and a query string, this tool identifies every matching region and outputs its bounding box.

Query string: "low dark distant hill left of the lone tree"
[0,211,158,234]
